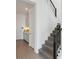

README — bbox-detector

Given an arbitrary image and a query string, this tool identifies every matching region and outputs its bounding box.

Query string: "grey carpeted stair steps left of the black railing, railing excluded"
[39,34,54,59]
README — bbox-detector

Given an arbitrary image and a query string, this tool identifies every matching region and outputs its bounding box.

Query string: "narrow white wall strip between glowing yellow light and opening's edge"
[29,6,36,48]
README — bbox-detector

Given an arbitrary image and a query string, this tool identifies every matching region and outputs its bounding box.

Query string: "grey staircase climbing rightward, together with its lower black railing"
[39,24,61,59]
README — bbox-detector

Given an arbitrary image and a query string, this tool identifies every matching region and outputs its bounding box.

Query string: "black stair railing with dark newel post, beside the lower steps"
[53,23,62,59]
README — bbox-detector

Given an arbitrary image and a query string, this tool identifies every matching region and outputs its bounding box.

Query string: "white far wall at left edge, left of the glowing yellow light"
[16,13,26,39]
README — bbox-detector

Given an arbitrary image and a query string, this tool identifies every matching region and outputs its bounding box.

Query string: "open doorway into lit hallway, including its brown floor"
[16,0,43,59]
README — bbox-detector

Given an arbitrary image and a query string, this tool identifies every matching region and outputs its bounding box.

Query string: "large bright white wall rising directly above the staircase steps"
[31,0,61,53]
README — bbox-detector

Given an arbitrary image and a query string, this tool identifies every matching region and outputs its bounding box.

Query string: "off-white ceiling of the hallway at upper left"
[16,0,33,14]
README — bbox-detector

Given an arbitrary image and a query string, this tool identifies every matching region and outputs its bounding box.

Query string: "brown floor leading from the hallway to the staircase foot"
[16,40,44,59]
